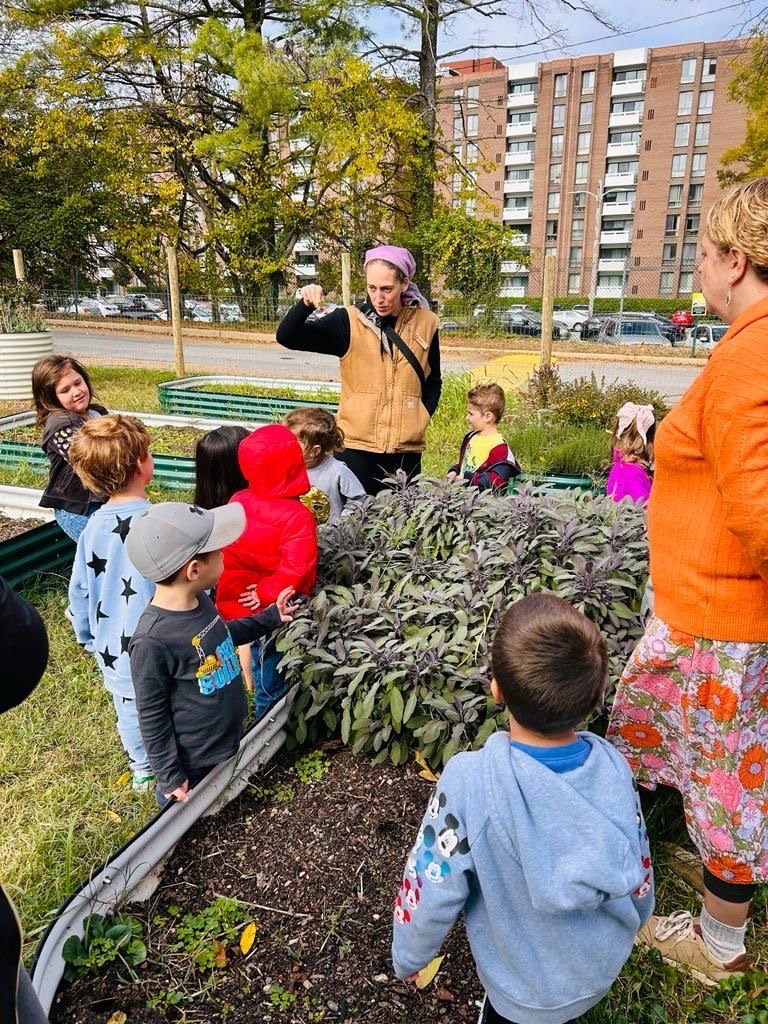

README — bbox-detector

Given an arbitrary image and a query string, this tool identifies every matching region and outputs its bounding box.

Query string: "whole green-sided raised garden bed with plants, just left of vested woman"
[158,376,339,421]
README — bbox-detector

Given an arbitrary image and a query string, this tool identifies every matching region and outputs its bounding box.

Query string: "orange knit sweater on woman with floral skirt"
[648,299,768,643]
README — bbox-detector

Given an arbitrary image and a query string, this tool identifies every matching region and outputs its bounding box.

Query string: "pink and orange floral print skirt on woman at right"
[607,616,768,885]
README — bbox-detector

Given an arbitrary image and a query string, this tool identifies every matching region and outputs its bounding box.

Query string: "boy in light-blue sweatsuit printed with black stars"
[68,415,155,792]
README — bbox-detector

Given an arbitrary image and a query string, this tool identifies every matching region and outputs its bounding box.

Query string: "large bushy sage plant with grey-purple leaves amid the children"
[278,481,647,765]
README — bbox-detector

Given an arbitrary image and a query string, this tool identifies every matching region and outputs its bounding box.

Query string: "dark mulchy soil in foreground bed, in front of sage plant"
[50,744,481,1024]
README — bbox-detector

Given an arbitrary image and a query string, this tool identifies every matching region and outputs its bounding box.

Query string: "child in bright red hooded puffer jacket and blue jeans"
[216,424,317,718]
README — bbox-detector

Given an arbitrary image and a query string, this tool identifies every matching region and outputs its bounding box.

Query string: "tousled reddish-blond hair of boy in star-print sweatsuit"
[69,413,150,498]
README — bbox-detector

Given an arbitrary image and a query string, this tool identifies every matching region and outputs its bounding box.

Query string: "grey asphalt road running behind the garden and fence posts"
[53,330,700,400]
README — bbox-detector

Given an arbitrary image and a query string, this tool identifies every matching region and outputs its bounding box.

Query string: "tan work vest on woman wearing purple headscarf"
[337,306,438,453]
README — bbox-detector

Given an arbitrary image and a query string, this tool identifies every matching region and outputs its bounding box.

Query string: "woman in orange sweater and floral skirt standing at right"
[608,178,768,984]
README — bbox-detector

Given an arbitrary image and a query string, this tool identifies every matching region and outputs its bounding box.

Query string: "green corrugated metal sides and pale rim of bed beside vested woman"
[158,377,339,423]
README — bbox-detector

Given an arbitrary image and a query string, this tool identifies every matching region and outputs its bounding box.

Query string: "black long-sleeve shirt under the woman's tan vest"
[276,301,442,417]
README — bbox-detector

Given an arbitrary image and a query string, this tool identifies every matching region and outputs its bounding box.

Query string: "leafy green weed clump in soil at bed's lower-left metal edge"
[61,913,146,981]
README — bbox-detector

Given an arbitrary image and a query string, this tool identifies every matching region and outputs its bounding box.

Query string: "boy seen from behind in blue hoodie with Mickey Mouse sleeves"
[392,594,653,1024]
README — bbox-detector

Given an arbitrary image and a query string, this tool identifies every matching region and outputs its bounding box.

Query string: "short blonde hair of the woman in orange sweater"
[707,177,768,284]
